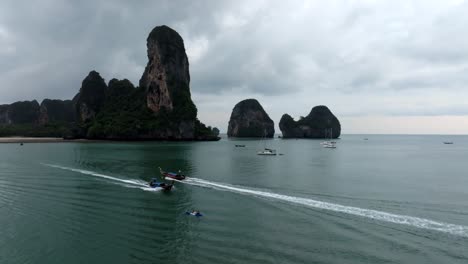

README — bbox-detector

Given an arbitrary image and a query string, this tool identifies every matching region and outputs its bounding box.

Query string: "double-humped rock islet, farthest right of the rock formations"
[279,105,341,138]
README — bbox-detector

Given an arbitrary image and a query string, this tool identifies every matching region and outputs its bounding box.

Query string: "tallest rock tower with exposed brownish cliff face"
[140,26,197,139]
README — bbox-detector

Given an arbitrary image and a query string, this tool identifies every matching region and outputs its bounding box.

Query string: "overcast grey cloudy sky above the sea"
[0,0,468,134]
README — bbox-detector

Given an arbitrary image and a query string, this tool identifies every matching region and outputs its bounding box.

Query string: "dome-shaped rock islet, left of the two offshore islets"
[228,99,275,138]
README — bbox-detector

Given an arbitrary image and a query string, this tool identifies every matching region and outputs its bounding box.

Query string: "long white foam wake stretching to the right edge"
[184,178,468,237]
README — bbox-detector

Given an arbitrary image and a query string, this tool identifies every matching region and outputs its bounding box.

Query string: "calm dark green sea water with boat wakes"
[0,135,468,263]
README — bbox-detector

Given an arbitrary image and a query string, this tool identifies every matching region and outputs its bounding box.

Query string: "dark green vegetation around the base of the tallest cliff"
[82,79,213,139]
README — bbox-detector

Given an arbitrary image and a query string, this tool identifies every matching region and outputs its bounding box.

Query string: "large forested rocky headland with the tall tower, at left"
[0,26,219,140]
